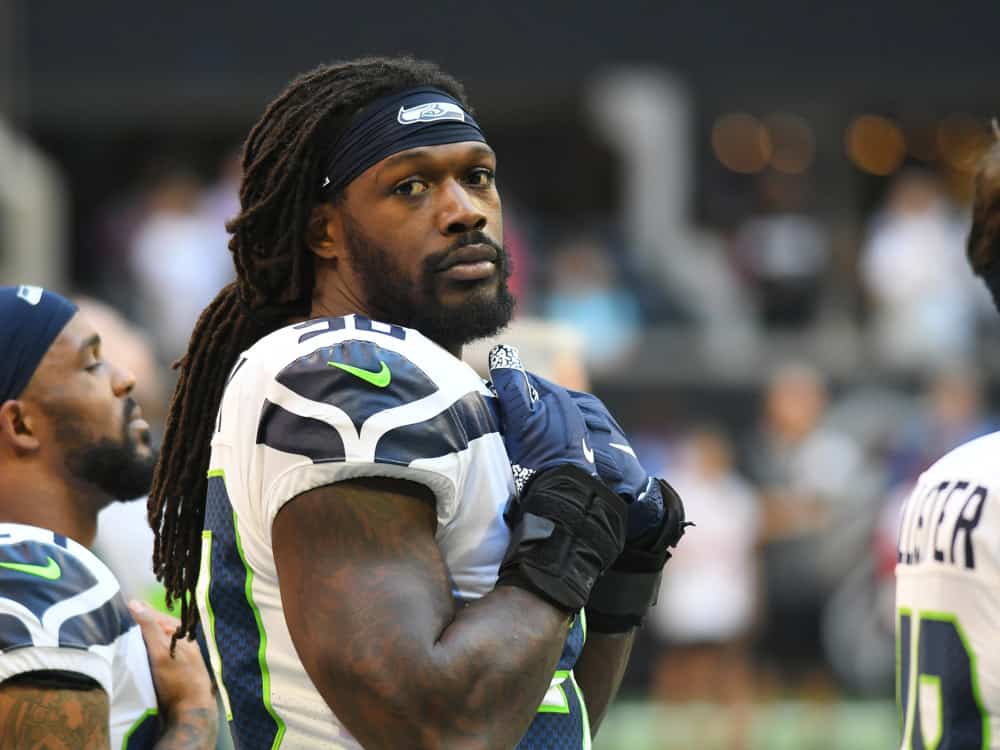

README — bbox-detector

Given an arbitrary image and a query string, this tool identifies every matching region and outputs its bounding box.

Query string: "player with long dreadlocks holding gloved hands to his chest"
[150,54,684,750]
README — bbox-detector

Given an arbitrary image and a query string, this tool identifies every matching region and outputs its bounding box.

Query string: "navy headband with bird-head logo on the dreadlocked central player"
[320,86,486,195]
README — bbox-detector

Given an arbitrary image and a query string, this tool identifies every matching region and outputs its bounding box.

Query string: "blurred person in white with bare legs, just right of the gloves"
[649,427,763,750]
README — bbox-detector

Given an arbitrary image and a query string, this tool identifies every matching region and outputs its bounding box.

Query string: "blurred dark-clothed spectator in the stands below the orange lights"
[734,178,830,328]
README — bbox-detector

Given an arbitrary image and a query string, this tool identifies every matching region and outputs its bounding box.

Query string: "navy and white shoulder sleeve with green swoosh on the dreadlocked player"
[256,338,498,528]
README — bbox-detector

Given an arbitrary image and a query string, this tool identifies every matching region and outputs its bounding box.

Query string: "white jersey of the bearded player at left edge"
[0,523,159,750]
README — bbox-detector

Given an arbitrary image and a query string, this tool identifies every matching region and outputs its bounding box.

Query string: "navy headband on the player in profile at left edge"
[0,286,76,404]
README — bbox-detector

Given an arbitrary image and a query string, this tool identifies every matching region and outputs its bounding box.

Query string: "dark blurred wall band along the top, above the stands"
[7,0,1000,127]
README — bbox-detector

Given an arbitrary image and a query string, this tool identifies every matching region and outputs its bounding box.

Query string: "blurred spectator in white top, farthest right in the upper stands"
[861,169,984,369]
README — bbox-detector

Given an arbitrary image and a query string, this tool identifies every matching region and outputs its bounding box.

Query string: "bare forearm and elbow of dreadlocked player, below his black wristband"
[317,586,568,750]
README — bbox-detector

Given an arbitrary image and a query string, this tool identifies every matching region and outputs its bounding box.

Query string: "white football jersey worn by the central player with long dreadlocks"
[197,315,589,750]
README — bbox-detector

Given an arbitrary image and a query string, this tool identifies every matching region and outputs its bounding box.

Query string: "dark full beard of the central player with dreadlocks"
[344,216,516,350]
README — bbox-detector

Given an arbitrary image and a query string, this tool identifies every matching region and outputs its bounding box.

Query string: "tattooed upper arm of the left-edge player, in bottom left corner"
[0,685,111,750]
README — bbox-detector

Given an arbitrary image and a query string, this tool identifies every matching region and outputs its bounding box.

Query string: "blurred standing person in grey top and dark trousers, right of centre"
[748,364,875,688]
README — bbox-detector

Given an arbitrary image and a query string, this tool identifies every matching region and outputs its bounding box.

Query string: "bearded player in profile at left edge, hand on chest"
[0,286,216,750]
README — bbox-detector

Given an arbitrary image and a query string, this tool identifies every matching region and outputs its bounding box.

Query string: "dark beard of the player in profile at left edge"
[49,398,157,501]
